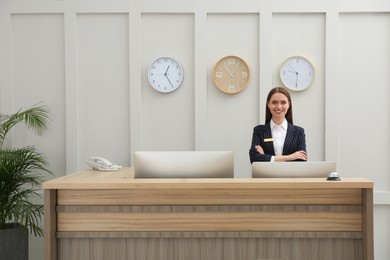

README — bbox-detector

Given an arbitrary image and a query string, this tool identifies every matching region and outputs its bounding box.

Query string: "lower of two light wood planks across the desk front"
[57,212,363,232]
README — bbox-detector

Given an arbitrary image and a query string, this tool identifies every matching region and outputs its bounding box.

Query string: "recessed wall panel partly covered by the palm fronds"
[11,14,65,176]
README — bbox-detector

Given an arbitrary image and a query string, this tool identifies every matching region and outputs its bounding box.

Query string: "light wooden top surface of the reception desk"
[43,167,373,189]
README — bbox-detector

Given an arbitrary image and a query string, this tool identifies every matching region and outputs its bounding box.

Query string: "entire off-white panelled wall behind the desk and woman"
[0,0,390,260]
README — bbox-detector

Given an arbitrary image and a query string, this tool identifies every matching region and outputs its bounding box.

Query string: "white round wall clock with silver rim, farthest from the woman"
[148,57,184,93]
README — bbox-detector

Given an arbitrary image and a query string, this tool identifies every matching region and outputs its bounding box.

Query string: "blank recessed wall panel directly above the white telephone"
[77,14,130,169]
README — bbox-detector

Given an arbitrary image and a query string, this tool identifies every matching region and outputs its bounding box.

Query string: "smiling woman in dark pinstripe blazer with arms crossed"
[249,87,307,163]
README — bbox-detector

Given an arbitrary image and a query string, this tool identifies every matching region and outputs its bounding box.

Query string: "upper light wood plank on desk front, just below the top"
[57,188,362,205]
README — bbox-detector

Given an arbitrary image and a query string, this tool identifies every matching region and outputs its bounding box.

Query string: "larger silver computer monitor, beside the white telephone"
[134,151,234,178]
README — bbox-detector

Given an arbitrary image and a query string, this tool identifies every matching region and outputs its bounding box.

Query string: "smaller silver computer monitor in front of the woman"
[252,161,336,178]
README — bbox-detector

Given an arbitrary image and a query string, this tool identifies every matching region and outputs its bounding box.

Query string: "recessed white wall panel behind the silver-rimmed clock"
[140,14,197,151]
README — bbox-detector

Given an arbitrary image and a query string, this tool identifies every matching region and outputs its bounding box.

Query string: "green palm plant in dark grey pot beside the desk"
[0,105,51,259]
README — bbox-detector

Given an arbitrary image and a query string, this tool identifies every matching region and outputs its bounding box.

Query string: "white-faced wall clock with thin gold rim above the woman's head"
[280,56,314,91]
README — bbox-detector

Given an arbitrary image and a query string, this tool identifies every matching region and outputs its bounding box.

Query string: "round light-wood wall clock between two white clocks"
[213,56,250,94]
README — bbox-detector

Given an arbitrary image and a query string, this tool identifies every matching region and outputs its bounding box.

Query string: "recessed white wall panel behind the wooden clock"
[205,13,259,177]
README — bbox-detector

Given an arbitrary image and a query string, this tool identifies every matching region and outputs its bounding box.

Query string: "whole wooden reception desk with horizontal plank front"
[43,168,374,260]
